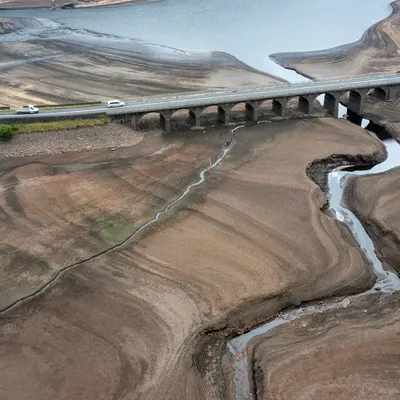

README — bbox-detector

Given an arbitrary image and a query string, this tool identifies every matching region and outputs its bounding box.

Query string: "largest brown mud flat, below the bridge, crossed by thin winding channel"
[0,118,384,400]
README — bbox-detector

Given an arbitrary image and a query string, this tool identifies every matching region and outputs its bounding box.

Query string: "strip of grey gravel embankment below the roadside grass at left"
[0,123,143,159]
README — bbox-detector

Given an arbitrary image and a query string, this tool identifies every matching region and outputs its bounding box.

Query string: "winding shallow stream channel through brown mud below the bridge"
[228,132,400,400]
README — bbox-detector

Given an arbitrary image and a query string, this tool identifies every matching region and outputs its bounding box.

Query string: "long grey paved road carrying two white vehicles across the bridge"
[0,74,400,121]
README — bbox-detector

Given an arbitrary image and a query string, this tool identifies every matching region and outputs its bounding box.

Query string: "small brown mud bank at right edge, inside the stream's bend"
[345,168,400,274]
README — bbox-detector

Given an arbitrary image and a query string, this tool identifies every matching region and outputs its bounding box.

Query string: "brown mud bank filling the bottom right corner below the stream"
[249,293,400,400]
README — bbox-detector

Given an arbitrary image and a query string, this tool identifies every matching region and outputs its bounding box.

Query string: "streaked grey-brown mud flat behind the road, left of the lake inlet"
[0,19,282,106]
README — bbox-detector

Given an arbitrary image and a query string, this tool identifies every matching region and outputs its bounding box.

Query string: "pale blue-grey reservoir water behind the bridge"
[0,0,391,81]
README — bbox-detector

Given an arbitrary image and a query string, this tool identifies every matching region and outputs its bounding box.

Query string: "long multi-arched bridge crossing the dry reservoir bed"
[108,74,400,132]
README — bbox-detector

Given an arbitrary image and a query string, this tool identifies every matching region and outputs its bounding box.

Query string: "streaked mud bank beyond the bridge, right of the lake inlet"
[271,1,400,79]
